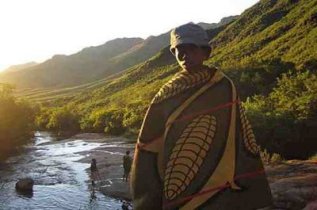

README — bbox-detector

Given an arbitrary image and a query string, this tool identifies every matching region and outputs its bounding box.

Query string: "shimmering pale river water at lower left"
[0,132,126,210]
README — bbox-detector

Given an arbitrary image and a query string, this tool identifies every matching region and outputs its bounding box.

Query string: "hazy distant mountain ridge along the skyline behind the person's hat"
[0,16,237,88]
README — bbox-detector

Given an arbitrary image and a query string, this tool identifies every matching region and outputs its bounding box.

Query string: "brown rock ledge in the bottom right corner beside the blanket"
[266,160,317,210]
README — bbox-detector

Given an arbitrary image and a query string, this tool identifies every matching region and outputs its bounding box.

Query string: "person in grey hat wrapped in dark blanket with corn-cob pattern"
[131,23,272,210]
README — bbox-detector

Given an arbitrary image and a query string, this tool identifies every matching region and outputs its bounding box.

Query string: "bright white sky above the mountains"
[0,0,258,71]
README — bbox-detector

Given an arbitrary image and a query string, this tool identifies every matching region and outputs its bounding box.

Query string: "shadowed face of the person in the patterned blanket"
[175,44,208,73]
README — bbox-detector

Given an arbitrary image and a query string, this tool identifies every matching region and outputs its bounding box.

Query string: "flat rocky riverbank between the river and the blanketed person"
[77,134,134,201]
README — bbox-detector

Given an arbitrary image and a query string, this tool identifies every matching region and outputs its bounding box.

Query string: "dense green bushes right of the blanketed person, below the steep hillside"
[244,71,317,156]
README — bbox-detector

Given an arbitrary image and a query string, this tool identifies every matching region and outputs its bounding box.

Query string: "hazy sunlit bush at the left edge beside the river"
[0,84,35,160]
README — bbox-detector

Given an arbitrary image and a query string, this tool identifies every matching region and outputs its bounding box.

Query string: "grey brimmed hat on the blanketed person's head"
[170,23,210,53]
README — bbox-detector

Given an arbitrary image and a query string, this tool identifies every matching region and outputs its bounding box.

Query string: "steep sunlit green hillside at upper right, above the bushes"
[210,0,317,69]
